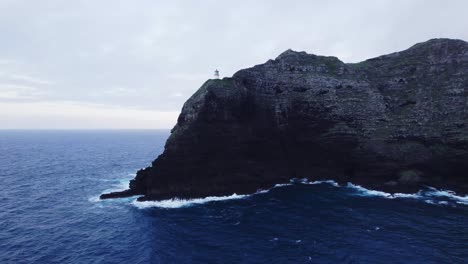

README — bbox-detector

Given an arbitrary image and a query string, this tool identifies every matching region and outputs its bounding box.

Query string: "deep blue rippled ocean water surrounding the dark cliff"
[0,131,468,263]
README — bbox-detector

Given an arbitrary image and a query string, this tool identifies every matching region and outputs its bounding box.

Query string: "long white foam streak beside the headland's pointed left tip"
[132,193,249,209]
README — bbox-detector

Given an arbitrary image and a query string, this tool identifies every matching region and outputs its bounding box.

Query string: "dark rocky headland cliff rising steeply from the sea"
[103,39,468,200]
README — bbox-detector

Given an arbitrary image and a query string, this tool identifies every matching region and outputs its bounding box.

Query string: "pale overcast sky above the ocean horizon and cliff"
[0,0,468,129]
